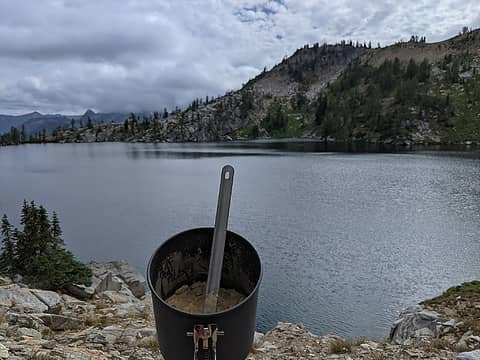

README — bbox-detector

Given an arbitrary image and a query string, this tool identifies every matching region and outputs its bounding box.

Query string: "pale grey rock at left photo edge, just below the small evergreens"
[0,285,48,313]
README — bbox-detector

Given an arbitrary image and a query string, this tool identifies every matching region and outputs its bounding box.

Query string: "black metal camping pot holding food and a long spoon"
[147,228,262,360]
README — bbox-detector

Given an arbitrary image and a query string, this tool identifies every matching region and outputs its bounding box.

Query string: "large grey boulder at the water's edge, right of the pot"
[390,305,452,345]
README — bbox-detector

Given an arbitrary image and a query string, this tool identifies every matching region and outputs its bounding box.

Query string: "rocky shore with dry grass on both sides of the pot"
[0,262,480,360]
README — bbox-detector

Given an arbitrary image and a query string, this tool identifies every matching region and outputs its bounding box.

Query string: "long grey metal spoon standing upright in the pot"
[203,165,234,314]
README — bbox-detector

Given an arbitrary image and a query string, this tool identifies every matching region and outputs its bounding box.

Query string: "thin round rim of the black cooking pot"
[146,226,263,318]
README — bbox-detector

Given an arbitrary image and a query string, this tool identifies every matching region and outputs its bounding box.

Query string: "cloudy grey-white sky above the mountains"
[0,0,480,114]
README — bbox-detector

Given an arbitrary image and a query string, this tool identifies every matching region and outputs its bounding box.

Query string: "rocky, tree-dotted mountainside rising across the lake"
[0,30,480,145]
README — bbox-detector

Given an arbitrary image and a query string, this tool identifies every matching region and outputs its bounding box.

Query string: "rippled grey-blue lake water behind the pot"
[0,142,480,338]
